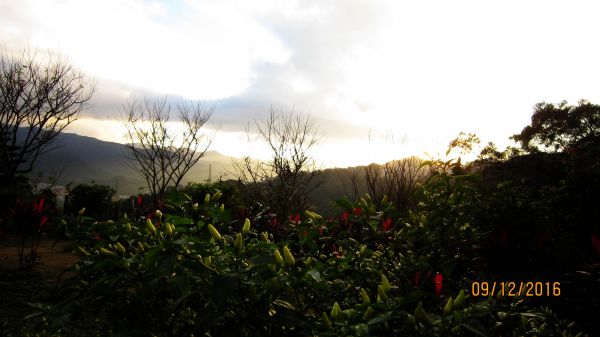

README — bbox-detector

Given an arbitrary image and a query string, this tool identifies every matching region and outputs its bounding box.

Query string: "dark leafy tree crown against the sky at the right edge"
[512,100,600,152]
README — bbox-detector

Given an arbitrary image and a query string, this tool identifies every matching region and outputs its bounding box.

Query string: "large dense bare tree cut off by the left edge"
[0,49,94,182]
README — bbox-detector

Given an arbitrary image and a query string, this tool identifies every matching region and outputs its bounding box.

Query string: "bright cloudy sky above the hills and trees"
[0,0,600,167]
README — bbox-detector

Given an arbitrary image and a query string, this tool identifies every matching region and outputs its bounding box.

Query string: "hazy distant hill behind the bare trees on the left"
[34,133,235,195]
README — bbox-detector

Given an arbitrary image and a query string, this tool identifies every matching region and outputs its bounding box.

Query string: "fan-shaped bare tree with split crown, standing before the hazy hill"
[124,98,215,207]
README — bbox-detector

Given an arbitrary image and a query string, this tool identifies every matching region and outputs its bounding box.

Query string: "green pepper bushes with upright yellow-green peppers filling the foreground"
[21,171,588,336]
